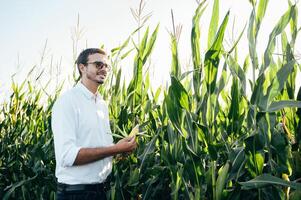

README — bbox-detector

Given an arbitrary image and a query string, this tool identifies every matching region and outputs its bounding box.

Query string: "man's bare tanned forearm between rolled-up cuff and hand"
[73,145,120,165]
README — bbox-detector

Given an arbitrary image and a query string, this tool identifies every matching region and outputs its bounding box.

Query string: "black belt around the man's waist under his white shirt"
[57,183,105,192]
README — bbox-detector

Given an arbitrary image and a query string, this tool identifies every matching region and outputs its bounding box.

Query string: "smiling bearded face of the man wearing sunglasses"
[82,53,109,84]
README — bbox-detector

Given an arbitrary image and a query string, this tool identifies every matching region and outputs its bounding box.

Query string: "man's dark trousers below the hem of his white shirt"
[56,183,107,200]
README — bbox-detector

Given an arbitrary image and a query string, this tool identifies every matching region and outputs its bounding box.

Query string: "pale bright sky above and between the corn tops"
[0,0,301,100]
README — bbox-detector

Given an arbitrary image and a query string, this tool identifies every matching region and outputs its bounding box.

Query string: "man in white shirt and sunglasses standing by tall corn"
[52,48,136,200]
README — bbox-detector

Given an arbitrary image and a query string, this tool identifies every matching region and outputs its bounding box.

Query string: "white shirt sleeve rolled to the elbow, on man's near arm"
[51,96,80,167]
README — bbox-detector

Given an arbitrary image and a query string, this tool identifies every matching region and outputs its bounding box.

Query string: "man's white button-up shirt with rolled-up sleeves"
[51,83,113,184]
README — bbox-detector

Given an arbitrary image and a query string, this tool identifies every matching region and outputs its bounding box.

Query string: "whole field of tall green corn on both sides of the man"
[0,0,301,200]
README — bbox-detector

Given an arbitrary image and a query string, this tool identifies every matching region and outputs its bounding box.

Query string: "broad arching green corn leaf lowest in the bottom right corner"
[239,174,301,190]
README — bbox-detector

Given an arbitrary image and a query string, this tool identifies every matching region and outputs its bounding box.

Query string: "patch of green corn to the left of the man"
[0,77,59,199]
